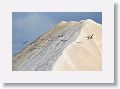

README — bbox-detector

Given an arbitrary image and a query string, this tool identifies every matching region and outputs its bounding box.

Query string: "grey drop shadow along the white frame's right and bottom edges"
[3,3,118,88]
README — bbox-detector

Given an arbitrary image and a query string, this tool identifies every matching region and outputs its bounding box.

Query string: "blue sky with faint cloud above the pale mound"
[12,12,102,55]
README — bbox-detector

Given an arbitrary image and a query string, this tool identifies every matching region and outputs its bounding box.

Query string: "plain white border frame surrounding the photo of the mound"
[0,0,114,83]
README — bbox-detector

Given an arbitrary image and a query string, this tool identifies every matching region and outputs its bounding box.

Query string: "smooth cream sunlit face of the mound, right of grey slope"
[53,20,102,71]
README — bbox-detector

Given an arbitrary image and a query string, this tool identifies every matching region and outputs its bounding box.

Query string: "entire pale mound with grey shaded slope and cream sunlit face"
[12,19,102,71]
